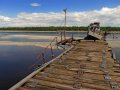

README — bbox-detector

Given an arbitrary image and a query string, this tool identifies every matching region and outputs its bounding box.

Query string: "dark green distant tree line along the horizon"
[0,26,120,31]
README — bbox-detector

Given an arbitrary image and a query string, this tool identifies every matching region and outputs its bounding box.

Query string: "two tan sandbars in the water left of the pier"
[0,35,59,48]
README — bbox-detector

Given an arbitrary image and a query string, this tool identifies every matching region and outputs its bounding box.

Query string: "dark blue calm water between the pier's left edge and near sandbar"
[0,45,63,90]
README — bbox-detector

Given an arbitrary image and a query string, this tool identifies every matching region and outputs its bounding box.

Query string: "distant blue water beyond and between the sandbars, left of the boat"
[0,32,86,42]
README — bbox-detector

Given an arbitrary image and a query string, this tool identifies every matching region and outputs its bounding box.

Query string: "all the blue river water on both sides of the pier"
[0,32,120,90]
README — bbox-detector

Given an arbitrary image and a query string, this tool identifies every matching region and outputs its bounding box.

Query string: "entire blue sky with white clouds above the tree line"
[0,0,120,27]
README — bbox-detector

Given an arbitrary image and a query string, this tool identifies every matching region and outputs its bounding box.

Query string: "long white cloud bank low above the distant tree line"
[0,6,120,27]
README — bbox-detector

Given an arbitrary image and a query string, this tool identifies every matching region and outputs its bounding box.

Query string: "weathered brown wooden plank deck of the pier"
[10,40,120,90]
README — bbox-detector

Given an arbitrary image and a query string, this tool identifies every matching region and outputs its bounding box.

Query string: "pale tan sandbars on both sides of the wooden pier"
[0,35,120,47]
